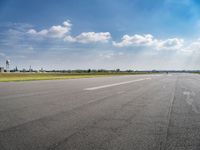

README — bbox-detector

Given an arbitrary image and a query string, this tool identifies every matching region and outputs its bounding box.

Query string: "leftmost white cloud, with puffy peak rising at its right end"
[27,20,72,38]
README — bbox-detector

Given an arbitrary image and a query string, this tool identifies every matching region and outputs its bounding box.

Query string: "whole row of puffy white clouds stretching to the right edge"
[27,20,200,52]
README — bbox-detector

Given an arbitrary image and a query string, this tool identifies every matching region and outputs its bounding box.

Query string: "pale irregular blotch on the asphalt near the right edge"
[183,91,199,113]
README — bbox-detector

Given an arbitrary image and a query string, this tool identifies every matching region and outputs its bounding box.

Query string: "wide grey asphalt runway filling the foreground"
[0,74,200,150]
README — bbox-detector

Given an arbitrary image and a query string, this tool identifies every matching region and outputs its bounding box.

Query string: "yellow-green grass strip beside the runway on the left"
[0,72,153,82]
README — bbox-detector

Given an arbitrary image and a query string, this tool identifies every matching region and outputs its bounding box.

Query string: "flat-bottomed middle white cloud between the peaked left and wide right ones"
[64,32,111,43]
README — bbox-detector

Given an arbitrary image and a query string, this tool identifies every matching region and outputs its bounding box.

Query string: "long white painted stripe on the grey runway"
[84,78,151,91]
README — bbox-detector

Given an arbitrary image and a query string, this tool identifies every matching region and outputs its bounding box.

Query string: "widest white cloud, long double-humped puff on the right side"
[113,34,184,50]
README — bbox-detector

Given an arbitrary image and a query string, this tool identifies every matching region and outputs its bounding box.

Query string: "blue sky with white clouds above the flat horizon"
[0,0,200,70]
